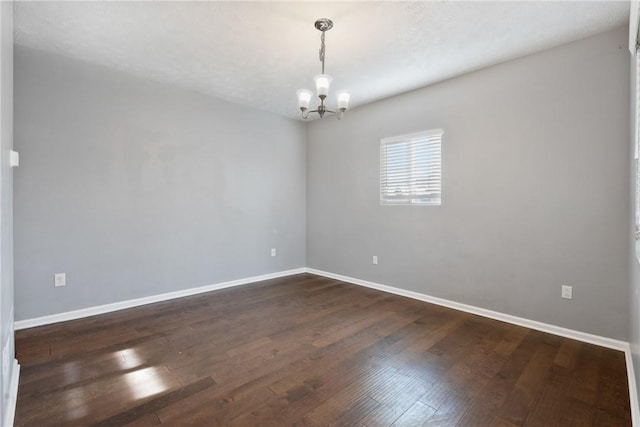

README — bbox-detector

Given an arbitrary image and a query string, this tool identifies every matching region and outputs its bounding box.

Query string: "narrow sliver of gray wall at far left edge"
[0,2,15,422]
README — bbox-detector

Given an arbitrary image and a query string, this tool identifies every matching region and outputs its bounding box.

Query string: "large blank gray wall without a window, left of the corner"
[14,46,306,320]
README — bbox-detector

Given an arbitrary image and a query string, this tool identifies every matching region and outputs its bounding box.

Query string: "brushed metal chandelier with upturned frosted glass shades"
[296,18,351,119]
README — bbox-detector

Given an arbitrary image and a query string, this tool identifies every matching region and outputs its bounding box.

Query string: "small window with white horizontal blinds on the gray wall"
[380,129,443,205]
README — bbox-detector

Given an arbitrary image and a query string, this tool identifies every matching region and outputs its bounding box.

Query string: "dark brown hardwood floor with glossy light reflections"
[16,274,631,427]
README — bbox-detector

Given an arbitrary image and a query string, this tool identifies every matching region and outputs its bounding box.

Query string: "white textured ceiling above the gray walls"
[14,1,629,117]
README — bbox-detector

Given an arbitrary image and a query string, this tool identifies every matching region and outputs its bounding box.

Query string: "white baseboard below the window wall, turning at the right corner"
[305,267,640,426]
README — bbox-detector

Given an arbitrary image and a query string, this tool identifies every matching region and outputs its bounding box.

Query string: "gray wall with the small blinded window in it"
[307,28,630,340]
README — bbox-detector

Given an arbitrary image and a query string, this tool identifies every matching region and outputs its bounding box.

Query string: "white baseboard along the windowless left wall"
[14,268,305,330]
